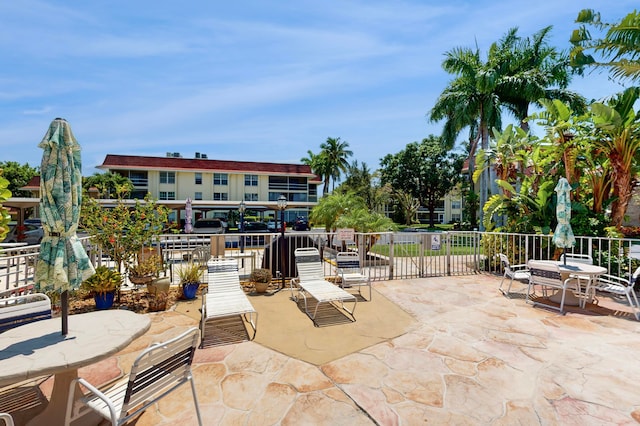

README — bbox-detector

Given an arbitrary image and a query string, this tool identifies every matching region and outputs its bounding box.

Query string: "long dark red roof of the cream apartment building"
[98,154,321,182]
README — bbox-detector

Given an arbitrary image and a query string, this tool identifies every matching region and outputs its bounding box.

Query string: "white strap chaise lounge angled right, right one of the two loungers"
[289,247,358,326]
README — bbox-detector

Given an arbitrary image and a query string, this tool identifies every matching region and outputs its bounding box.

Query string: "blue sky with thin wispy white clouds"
[0,0,638,176]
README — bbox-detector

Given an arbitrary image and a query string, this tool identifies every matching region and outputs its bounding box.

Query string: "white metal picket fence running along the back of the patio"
[0,231,640,297]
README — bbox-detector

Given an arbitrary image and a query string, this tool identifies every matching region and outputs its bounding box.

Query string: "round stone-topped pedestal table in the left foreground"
[0,310,151,425]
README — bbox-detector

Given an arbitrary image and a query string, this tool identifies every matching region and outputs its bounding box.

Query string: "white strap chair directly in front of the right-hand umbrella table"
[526,260,586,314]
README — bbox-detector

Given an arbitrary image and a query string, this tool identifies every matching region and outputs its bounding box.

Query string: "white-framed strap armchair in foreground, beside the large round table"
[65,327,202,426]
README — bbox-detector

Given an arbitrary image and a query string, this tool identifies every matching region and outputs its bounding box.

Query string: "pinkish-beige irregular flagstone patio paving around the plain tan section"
[56,275,640,426]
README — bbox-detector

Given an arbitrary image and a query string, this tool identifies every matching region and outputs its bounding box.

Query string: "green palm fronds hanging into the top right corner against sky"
[570,9,640,81]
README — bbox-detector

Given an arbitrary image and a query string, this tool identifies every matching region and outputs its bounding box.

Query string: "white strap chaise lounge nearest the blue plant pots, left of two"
[200,258,258,347]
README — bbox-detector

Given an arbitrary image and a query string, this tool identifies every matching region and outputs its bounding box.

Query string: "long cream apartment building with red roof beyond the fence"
[98,152,321,226]
